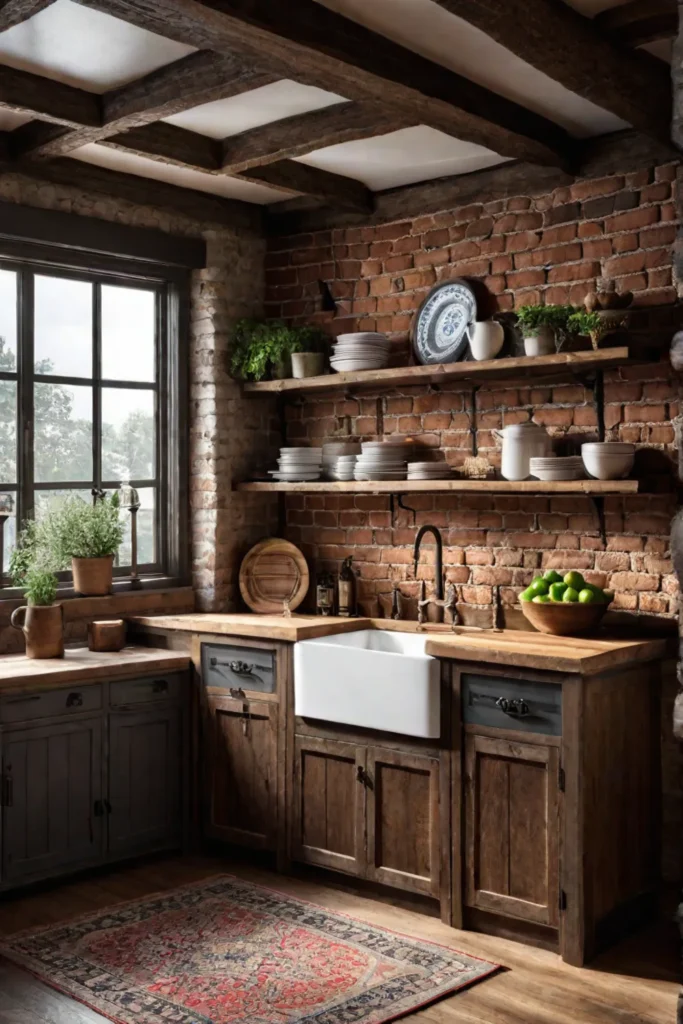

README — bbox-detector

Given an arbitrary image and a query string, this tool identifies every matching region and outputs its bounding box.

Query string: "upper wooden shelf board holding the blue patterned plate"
[244,346,629,394]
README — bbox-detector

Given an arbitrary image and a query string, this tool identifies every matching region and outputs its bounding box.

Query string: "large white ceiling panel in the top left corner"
[0,0,195,92]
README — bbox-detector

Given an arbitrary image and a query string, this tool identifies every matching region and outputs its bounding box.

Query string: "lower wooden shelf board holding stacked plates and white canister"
[234,479,639,497]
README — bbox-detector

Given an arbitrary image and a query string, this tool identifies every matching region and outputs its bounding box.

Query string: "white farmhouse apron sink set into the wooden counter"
[294,630,441,739]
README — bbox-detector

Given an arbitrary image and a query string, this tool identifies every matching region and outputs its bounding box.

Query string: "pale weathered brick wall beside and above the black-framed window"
[0,174,276,614]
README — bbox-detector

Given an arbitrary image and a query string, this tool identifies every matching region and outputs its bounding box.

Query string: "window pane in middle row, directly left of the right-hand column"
[34,384,92,483]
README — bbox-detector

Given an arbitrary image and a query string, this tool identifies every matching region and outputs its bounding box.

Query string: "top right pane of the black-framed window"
[102,285,156,382]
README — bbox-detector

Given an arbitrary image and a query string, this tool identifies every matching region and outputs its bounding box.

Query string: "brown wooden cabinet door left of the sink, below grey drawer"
[206,696,279,850]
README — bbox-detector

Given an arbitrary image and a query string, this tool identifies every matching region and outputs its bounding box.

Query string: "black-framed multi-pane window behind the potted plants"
[0,254,186,587]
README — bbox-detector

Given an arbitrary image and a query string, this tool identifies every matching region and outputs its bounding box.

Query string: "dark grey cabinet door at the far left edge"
[2,718,103,882]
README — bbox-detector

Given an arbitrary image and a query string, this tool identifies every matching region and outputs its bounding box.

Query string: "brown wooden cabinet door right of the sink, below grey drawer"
[465,735,559,927]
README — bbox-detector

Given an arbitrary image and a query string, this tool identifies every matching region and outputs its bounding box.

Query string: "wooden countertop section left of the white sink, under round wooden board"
[127,611,373,642]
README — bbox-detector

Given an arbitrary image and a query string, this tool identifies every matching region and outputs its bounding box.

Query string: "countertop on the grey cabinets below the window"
[0,647,190,695]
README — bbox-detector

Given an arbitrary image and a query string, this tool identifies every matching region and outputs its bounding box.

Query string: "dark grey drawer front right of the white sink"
[463,673,562,736]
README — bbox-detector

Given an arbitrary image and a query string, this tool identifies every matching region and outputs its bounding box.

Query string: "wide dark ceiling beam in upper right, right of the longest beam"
[436,0,671,140]
